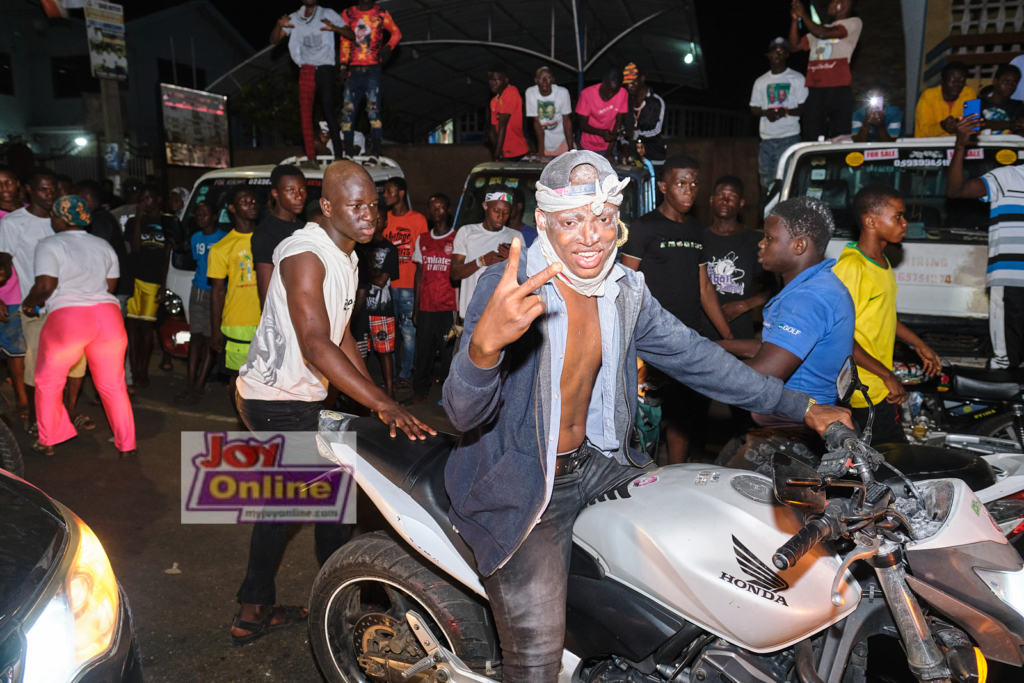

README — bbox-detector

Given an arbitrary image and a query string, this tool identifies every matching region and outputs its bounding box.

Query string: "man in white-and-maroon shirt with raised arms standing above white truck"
[790,0,863,141]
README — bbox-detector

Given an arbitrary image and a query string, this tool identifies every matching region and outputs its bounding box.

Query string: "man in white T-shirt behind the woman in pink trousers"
[0,166,86,433]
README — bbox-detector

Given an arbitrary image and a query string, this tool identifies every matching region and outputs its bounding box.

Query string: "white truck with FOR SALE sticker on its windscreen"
[768,135,1024,355]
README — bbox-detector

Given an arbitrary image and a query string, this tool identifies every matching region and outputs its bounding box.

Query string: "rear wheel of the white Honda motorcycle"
[308,531,501,683]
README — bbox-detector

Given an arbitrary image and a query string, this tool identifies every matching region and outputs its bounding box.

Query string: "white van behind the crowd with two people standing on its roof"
[165,157,404,319]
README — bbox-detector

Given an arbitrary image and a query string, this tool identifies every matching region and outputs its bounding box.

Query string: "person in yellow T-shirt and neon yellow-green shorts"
[206,185,260,401]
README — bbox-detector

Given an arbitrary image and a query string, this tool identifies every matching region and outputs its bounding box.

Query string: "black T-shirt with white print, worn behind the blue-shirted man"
[700,227,764,340]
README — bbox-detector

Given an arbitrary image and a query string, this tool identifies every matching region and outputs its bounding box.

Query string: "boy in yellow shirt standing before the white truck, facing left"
[833,185,942,445]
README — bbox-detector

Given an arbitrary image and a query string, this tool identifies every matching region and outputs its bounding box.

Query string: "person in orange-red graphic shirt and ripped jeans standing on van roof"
[325,0,401,157]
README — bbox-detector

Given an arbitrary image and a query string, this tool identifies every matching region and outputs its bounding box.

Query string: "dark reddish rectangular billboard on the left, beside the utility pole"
[160,83,231,168]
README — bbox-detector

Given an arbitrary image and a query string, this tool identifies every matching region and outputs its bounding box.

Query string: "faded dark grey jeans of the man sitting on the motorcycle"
[483,451,643,683]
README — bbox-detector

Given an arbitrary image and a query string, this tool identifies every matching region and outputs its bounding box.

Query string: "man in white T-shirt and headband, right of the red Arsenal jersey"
[451,190,522,319]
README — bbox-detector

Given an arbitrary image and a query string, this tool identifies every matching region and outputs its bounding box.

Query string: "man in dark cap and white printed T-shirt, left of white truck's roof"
[751,37,807,191]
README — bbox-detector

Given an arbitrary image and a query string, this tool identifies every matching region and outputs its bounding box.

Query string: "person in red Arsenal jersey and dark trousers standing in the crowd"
[413,193,459,403]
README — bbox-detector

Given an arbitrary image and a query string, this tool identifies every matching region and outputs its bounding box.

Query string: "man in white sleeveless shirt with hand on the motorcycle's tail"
[231,161,435,643]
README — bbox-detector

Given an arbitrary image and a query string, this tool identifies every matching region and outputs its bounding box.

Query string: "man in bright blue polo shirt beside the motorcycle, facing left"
[718,197,856,429]
